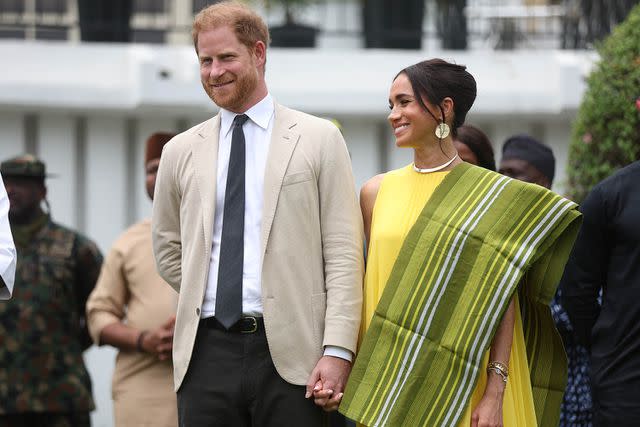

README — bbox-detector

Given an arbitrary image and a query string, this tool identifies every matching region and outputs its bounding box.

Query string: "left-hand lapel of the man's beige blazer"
[192,114,220,255]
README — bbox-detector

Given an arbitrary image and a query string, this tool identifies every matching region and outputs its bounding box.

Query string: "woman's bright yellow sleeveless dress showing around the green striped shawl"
[360,165,537,427]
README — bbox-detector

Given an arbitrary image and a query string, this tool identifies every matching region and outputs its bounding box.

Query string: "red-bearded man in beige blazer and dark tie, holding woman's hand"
[152,2,363,426]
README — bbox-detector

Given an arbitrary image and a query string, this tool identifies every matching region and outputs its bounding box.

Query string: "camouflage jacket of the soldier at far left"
[0,218,102,414]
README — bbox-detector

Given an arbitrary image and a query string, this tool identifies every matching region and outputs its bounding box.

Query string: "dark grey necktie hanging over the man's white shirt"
[215,114,249,329]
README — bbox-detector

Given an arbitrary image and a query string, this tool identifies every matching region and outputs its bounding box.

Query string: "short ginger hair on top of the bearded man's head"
[191,1,270,52]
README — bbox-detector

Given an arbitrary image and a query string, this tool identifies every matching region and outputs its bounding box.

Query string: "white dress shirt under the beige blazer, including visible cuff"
[200,94,353,361]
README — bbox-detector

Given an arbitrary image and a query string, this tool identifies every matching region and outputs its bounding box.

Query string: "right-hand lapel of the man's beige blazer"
[262,104,300,257]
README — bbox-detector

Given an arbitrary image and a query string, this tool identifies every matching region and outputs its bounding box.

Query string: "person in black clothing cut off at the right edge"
[560,161,640,427]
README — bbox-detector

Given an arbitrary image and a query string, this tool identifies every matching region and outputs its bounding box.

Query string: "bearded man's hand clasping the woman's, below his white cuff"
[305,356,351,412]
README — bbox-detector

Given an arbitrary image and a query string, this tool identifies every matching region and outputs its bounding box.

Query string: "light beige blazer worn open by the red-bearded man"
[152,104,363,390]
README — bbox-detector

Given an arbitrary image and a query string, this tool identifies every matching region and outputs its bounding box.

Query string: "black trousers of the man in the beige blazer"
[178,321,327,427]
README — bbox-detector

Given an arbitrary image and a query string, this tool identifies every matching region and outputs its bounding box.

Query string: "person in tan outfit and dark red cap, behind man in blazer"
[87,133,178,427]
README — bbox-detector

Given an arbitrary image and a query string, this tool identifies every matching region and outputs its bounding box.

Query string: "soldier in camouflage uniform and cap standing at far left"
[0,155,102,427]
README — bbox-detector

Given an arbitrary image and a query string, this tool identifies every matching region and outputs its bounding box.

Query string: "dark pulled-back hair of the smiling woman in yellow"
[394,58,476,137]
